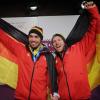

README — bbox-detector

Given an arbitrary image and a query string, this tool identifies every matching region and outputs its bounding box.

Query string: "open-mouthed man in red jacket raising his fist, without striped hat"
[52,1,100,100]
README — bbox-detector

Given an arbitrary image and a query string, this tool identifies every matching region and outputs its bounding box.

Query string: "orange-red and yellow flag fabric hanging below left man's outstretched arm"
[0,42,18,88]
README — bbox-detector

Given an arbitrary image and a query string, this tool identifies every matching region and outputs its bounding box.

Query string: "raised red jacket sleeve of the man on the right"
[79,7,99,55]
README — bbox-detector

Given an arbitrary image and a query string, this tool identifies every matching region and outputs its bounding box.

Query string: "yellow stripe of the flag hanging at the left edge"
[0,56,18,88]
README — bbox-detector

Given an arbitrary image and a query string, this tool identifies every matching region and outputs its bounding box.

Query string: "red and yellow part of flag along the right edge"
[88,20,100,96]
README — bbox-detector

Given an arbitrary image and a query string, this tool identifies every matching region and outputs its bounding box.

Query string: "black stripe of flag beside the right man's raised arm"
[66,12,89,46]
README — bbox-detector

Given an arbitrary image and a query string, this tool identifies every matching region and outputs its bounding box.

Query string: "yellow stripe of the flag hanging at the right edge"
[88,34,100,90]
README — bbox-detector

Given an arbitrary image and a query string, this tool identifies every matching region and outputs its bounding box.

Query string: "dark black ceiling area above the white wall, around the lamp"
[0,0,100,17]
